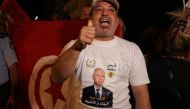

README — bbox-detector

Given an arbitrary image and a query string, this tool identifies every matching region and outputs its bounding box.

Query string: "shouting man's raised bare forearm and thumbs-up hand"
[51,20,95,83]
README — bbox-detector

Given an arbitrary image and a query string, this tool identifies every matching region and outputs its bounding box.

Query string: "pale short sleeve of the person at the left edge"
[3,37,18,66]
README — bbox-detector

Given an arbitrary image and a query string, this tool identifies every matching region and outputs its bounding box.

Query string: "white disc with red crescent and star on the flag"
[28,55,84,109]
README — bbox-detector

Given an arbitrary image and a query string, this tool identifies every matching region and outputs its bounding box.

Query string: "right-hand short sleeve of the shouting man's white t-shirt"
[129,45,150,86]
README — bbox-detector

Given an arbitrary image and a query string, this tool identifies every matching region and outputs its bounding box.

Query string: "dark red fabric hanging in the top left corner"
[0,0,31,23]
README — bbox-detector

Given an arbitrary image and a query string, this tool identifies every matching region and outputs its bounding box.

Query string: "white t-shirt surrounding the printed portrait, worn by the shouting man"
[76,36,150,109]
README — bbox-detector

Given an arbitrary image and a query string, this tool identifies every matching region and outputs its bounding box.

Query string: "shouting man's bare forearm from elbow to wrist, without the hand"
[51,40,83,83]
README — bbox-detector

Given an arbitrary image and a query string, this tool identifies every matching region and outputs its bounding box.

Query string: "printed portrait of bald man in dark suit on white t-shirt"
[81,68,113,108]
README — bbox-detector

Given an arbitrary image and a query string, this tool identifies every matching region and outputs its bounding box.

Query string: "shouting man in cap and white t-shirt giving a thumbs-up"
[52,0,151,109]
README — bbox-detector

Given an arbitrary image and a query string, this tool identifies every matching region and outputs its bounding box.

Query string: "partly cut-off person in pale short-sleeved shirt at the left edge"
[0,11,18,109]
